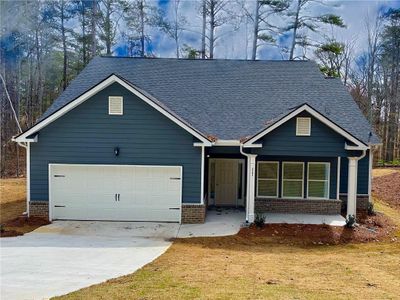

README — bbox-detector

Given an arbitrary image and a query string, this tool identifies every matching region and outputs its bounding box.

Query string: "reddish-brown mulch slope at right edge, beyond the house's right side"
[372,172,400,209]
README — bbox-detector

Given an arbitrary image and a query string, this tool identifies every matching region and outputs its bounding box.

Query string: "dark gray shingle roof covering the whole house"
[40,57,379,143]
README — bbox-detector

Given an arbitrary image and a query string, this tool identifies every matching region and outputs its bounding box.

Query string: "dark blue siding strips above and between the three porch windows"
[256,156,337,199]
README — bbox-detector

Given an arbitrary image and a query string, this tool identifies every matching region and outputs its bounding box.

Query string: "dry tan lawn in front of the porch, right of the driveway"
[60,170,400,299]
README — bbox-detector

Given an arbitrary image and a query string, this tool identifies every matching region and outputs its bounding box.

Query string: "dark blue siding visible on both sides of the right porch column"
[340,151,369,195]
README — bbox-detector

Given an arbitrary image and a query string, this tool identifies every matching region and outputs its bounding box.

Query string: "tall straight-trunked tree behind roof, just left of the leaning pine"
[247,0,290,60]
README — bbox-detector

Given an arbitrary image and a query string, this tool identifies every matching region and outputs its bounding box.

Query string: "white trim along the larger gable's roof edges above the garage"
[13,75,211,146]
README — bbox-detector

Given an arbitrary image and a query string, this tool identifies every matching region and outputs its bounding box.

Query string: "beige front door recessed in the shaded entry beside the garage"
[215,159,238,206]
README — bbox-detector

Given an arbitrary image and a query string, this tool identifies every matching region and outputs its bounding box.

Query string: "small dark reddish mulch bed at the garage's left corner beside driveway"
[0,216,50,237]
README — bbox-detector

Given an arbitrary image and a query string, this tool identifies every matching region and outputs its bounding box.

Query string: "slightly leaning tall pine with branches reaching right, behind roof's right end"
[286,0,346,60]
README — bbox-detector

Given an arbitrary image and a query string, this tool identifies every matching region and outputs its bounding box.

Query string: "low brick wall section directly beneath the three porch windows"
[254,198,342,215]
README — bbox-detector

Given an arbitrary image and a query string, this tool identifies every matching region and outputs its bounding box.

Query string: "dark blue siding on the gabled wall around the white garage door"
[31,84,201,203]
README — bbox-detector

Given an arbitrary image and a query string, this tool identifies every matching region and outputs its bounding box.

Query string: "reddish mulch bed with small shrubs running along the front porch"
[238,213,397,245]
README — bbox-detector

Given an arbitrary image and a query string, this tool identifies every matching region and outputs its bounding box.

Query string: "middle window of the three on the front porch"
[282,162,304,198]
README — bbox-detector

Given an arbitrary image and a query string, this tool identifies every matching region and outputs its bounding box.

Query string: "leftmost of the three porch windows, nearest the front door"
[257,161,279,197]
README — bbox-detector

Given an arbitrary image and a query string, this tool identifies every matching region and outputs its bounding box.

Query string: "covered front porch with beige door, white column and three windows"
[204,147,365,226]
